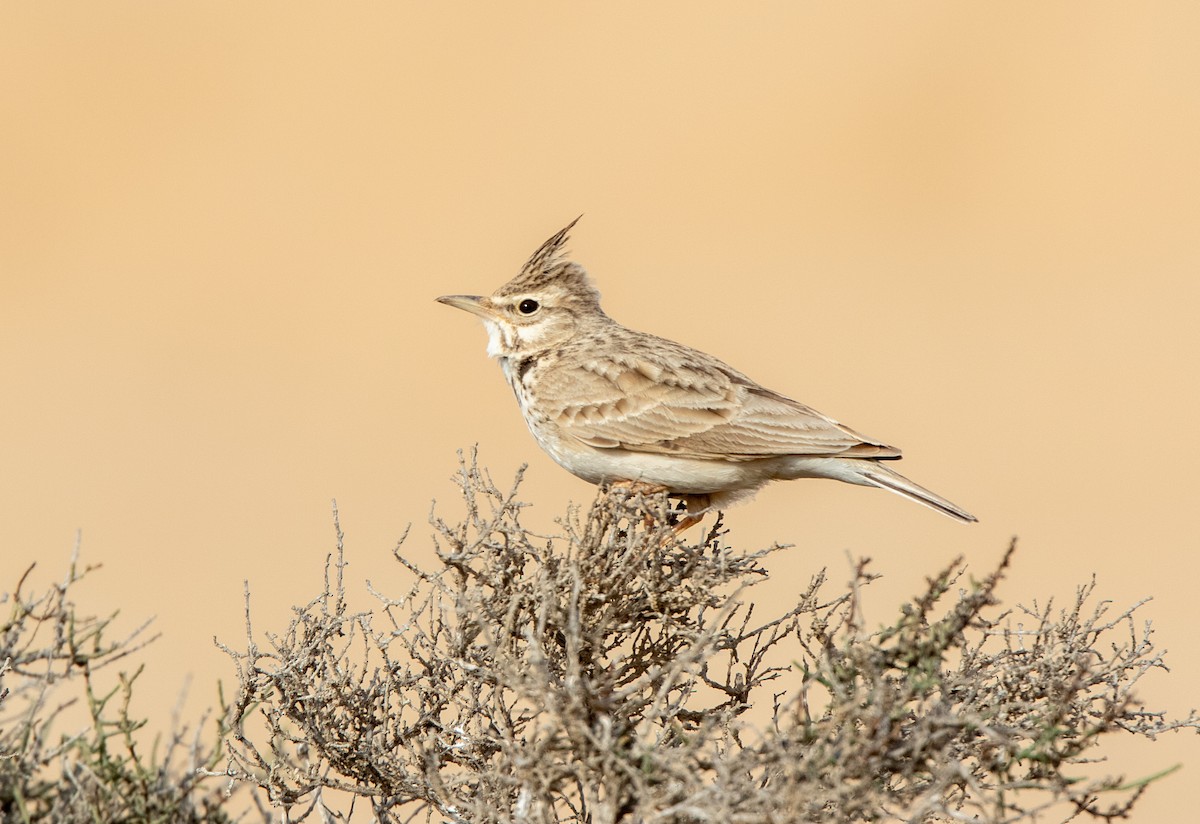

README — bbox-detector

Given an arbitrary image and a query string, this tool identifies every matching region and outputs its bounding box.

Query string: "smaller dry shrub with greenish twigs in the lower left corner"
[0,548,233,824]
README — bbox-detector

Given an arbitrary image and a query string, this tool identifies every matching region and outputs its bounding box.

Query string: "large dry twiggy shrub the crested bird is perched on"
[213,459,1198,824]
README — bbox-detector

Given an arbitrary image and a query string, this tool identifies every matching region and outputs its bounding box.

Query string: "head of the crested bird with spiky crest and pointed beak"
[438,218,605,357]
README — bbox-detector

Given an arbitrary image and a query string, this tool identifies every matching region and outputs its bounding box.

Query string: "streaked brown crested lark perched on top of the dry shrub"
[437,218,977,530]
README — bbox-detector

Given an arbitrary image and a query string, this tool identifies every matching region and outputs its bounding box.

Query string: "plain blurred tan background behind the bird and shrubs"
[0,0,1200,822]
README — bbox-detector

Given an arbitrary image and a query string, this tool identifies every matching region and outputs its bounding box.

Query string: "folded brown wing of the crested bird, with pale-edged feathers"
[536,347,900,461]
